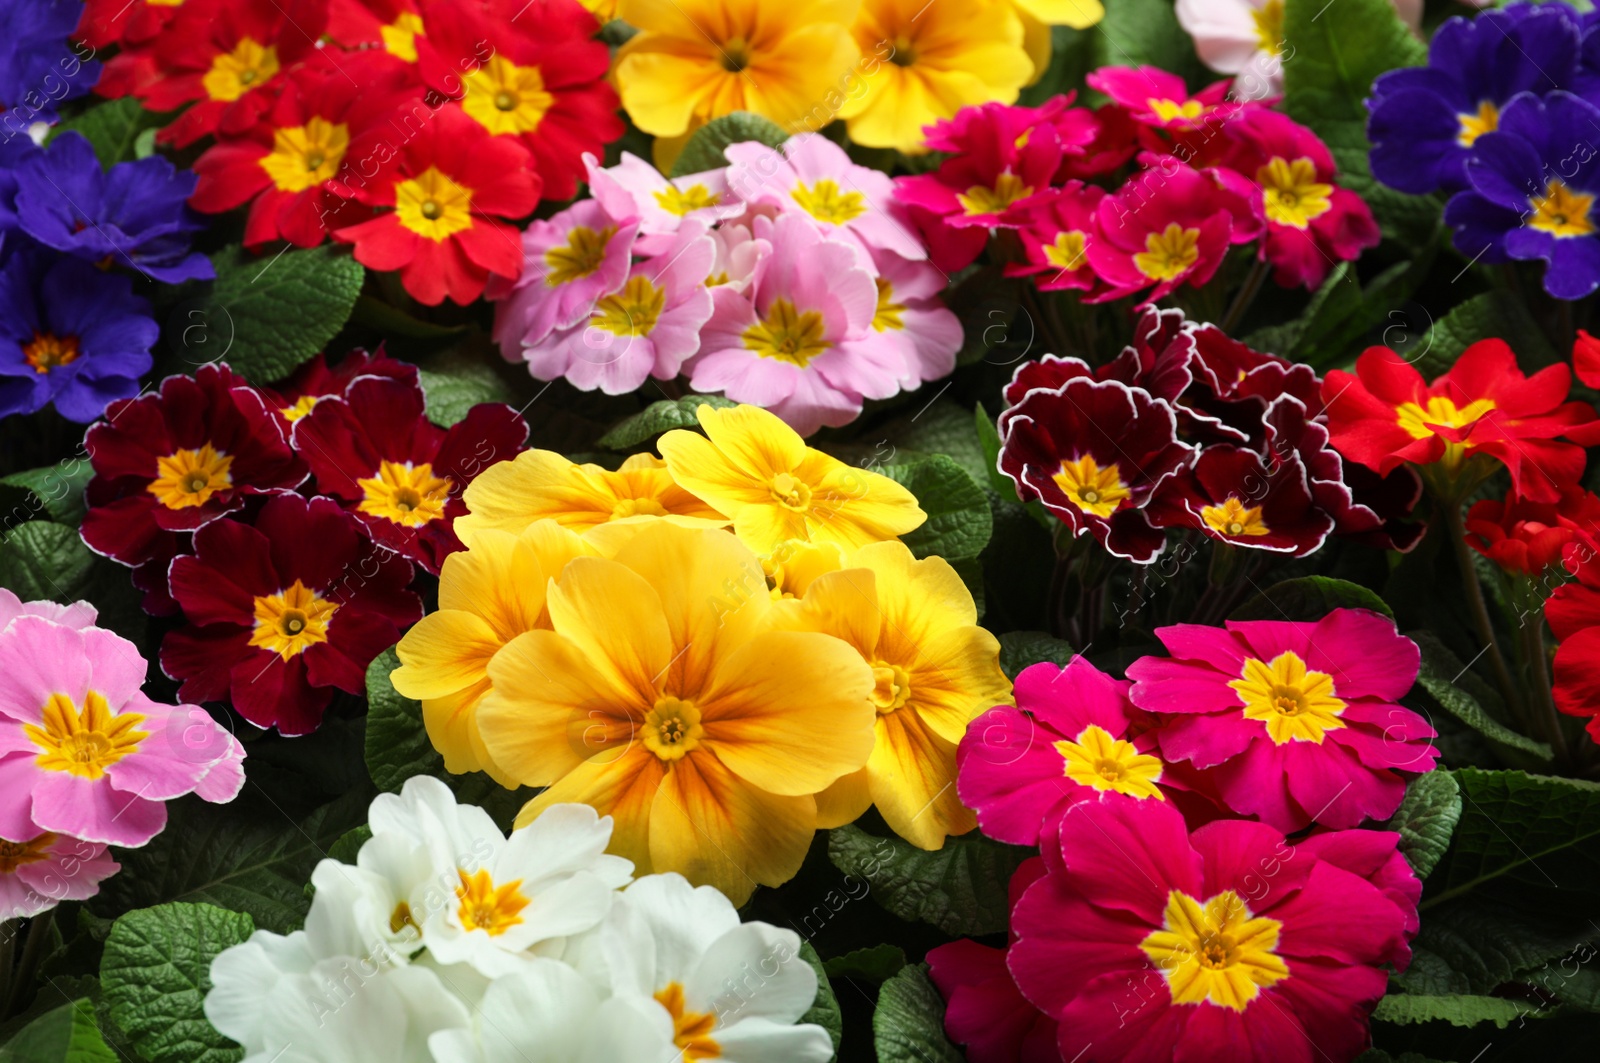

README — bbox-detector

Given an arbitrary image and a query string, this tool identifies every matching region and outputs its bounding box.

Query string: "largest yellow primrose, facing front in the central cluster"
[478,520,874,905]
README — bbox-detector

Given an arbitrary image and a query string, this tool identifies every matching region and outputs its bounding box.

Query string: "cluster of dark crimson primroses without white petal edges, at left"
[82,352,528,735]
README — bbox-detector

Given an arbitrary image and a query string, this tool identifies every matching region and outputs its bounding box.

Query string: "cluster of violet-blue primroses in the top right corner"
[1368,3,1600,299]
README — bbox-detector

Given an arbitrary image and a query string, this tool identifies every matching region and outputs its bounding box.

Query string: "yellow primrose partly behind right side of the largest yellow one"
[779,543,1011,848]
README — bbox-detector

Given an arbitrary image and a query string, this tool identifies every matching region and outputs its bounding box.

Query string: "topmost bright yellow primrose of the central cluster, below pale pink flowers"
[652,405,928,554]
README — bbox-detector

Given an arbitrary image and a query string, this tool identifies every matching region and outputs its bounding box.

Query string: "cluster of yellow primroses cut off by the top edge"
[614,0,1106,165]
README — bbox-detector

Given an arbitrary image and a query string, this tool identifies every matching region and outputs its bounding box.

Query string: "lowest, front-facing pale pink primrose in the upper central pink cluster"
[683,215,904,435]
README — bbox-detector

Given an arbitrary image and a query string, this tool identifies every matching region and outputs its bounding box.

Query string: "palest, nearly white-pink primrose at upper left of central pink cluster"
[584,152,744,255]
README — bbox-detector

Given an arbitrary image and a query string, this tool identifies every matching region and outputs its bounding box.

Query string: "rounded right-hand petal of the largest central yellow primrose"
[699,631,875,794]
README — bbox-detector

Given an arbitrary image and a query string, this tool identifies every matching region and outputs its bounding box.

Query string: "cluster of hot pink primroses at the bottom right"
[928,608,1438,1063]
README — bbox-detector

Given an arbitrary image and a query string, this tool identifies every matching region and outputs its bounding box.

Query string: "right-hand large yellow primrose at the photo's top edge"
[838,0,1048,152]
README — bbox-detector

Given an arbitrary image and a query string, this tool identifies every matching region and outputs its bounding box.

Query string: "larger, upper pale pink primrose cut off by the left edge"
[0,616,243,847]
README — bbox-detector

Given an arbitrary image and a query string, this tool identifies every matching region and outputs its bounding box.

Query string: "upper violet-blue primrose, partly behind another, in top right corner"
[1366,3,1600,195]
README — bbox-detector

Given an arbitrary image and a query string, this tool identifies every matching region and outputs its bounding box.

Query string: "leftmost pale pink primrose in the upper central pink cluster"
[488,200,638,362]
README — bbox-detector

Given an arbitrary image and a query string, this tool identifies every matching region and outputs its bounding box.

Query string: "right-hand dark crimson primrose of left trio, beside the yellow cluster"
[293,376,528,573]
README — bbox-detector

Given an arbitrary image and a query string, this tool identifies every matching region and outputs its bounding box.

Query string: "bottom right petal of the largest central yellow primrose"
[643,751,816,905]
